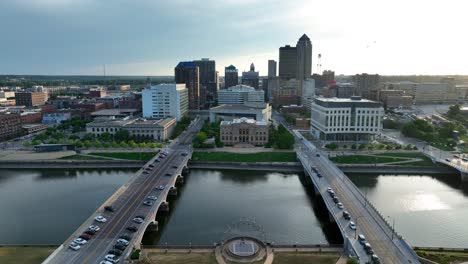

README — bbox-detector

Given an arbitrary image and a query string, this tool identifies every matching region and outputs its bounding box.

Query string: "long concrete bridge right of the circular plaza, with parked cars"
[294,131,420,264]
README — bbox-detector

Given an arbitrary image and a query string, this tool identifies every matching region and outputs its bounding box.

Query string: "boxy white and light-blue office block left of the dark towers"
[142,84,188,121]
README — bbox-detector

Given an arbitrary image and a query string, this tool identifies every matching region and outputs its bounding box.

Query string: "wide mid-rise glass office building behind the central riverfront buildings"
[218,84,265,105]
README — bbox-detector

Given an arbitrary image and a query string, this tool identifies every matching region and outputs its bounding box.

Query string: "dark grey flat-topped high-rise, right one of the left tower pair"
[193,58,218,108]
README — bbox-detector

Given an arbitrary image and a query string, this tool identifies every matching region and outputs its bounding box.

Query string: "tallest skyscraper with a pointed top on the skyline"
[296,34,312,80]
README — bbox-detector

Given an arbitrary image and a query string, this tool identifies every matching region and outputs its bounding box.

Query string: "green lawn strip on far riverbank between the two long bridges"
[192,152,297,162]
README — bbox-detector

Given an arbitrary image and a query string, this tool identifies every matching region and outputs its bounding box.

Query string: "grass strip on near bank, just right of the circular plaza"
[273,252,340,264]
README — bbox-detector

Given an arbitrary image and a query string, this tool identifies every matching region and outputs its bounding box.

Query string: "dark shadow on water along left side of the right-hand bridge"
[299,173,343,245]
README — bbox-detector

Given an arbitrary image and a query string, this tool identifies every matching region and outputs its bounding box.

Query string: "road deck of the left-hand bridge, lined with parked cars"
[44,119,202,263]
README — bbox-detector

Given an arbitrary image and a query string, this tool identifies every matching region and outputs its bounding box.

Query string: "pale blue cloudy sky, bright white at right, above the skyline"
[0,0,468,76]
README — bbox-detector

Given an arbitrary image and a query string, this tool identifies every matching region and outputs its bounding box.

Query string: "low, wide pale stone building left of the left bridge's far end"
[86,117,177,141]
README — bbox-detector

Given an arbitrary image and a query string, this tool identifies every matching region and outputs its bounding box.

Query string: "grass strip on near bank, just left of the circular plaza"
[148,253,218,264]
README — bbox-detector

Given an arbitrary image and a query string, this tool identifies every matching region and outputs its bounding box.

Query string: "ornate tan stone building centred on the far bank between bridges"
[220,117,268,146]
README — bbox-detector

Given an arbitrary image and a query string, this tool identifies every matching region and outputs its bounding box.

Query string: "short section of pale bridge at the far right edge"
[422,145,468,182]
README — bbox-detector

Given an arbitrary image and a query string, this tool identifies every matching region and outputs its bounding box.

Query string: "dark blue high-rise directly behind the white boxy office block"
[174,61,200,110]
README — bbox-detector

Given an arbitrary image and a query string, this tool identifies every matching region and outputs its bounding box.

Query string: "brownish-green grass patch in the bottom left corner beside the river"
[0,246,56,264]
